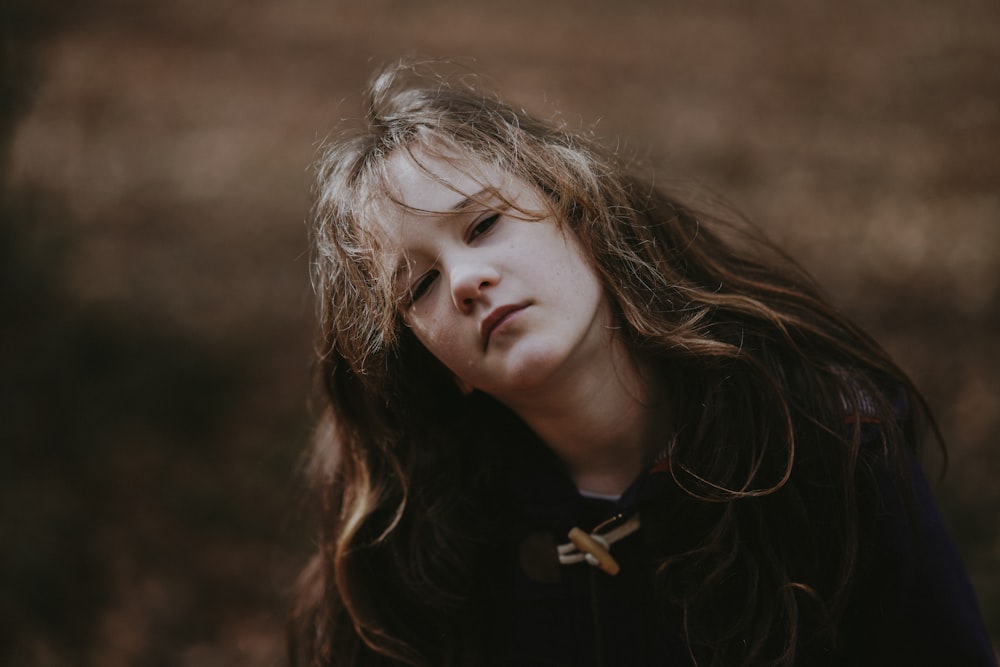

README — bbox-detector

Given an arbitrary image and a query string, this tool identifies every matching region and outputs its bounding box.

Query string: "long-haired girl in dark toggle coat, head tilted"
[290,66,995,667]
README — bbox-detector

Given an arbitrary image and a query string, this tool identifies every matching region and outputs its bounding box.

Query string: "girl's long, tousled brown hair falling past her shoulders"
[290,64,936,667]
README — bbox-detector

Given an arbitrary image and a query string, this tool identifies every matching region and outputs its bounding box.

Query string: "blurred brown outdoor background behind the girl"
[0,0,1000,667]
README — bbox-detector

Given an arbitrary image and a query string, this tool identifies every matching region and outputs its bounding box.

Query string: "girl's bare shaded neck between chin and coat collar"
[510,344,667,494]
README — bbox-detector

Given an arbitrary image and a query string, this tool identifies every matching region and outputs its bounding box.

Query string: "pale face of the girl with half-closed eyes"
[378,149,611,404]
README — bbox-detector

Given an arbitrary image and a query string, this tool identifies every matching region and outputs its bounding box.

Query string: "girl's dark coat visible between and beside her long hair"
[482,430,996,667]
